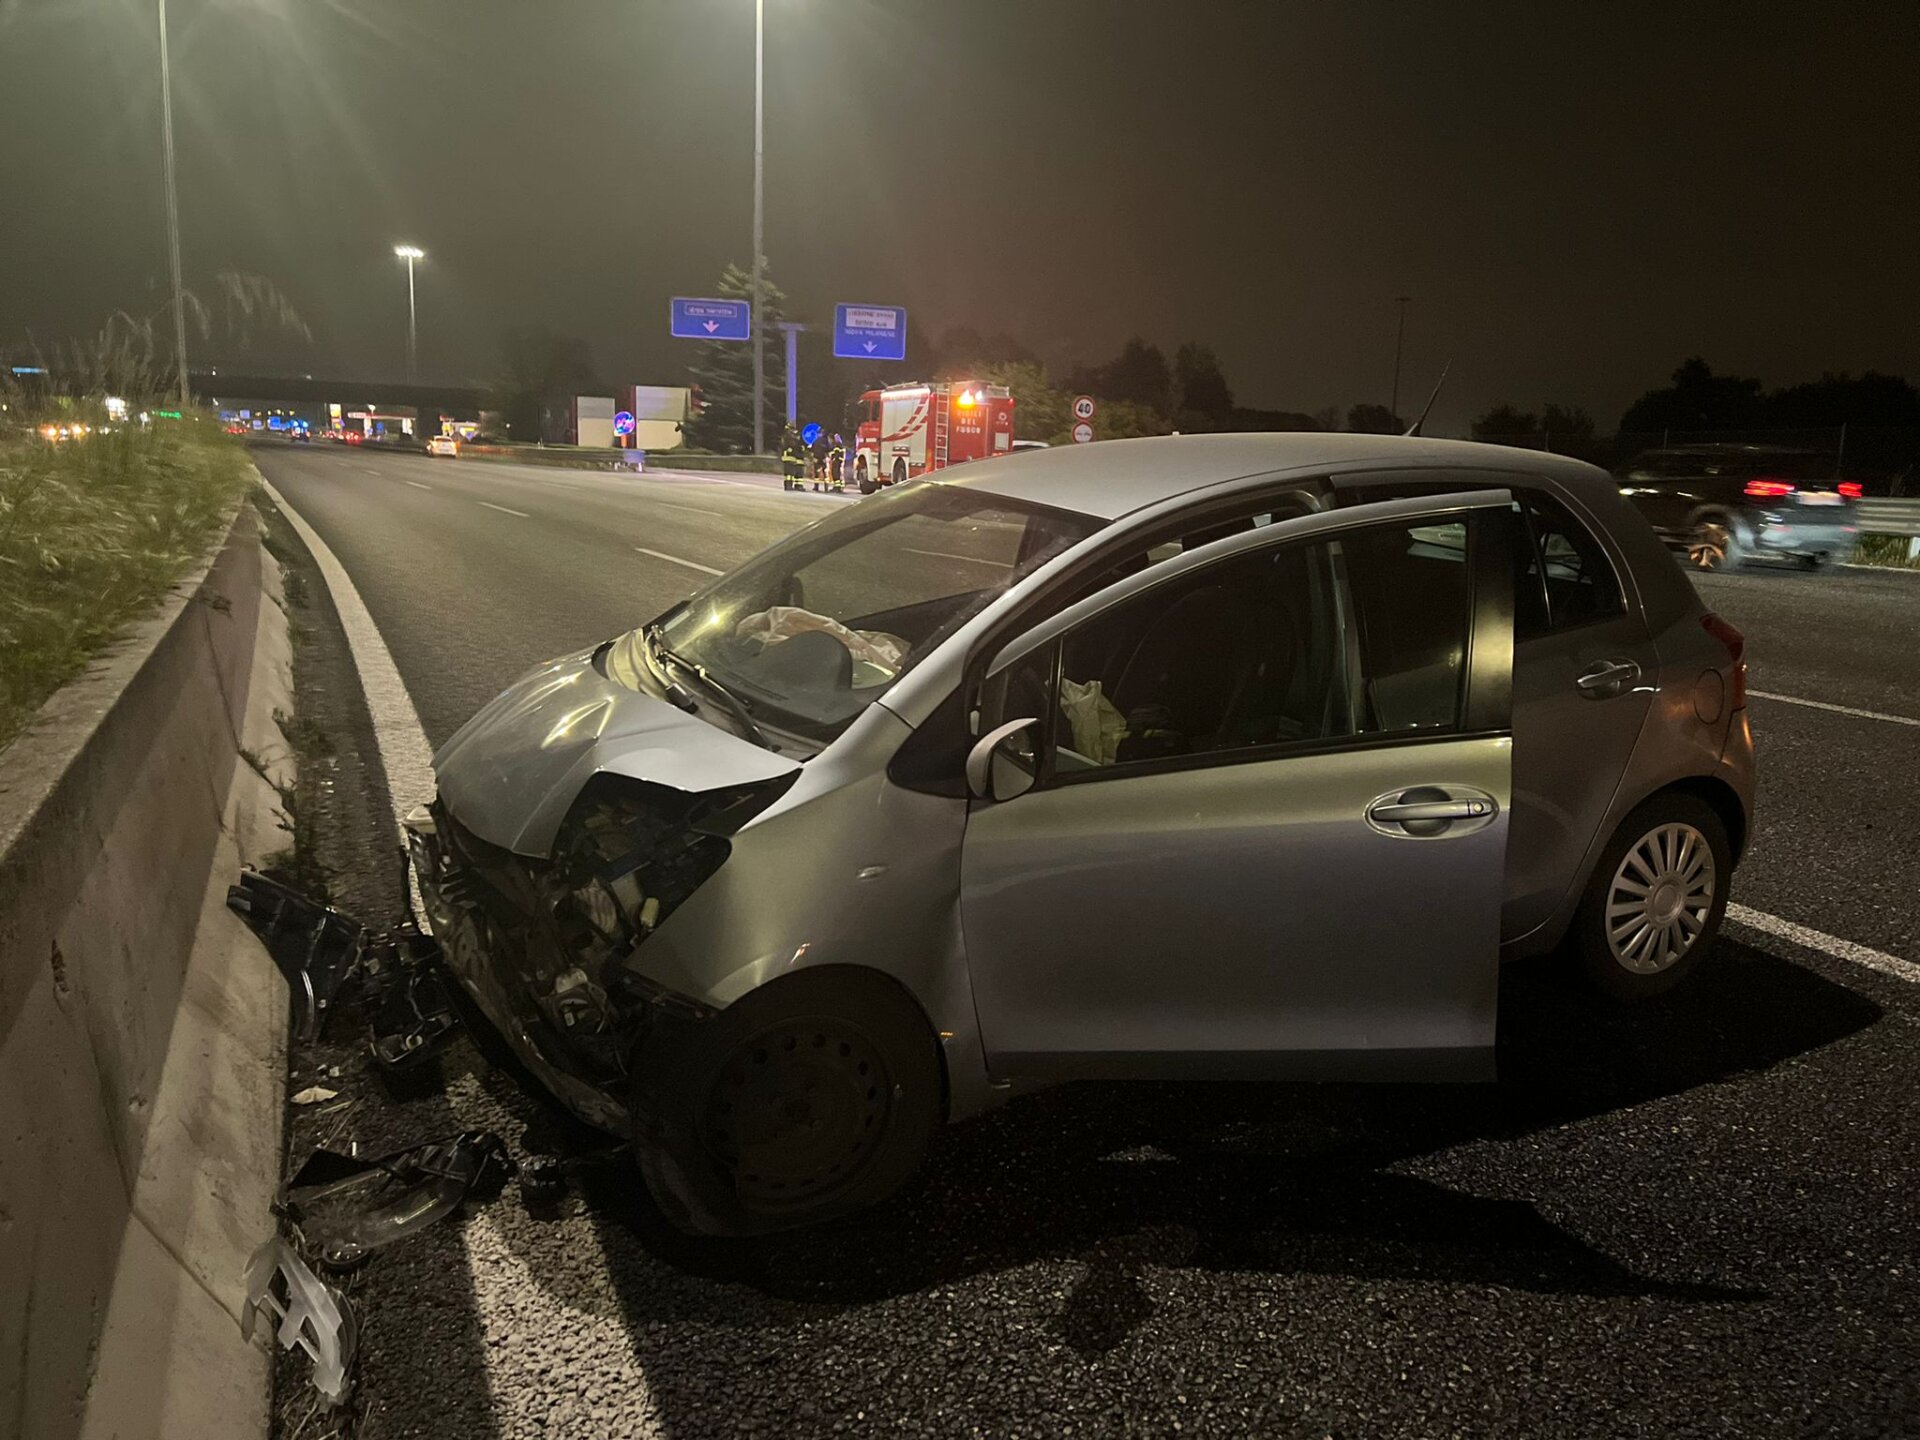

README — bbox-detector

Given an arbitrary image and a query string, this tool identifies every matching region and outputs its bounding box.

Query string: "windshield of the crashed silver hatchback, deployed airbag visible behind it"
[622,484,1102,739]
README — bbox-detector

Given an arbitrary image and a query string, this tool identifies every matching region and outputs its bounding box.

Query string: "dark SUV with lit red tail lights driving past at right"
[1617,445,1860,570]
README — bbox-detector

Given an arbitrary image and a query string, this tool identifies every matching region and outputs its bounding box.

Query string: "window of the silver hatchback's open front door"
[1013,518,1473,781]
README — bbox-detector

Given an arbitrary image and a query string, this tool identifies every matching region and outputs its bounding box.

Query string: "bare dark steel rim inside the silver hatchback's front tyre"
[705,1020,893,1208]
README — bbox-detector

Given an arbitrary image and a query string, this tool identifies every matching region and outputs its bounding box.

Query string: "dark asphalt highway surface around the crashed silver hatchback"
[257,449,1920,1436]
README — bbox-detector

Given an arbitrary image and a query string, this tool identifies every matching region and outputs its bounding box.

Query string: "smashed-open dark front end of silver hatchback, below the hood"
[405,772,797,1135]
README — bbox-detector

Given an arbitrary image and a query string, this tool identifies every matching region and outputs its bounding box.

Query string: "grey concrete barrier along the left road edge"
[0,505,290,1440]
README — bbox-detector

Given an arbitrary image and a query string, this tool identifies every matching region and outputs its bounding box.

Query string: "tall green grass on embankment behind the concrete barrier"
[0,419,252,749]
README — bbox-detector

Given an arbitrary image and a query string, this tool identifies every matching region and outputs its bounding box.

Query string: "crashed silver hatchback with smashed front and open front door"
[409,434,1753,1233]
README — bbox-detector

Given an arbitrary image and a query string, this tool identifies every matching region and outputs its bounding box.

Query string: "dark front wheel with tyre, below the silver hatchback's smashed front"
[634,970,941,1235]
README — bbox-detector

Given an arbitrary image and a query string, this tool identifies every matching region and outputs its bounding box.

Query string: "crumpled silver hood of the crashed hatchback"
[434,651,799,856]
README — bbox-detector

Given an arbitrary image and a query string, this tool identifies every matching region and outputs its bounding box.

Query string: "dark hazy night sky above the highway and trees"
[0,0,1920,430]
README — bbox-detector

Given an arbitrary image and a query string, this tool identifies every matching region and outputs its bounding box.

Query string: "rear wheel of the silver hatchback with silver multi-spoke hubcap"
[1574,795,1734,1000]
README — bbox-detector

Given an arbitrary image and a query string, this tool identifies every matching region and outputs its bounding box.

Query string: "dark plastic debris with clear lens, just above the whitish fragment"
[284,1131,513,1271]
